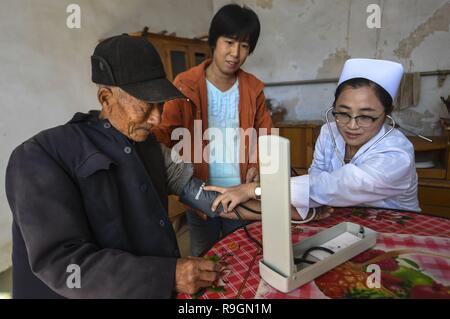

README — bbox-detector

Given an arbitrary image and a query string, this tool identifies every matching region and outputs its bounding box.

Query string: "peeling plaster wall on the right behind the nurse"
[213,0,450,129]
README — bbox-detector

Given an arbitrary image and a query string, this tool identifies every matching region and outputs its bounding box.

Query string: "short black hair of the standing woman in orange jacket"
[208,4,261,53]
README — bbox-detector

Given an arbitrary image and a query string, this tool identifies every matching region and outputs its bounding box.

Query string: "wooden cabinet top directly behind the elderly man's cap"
[130,32,211,81]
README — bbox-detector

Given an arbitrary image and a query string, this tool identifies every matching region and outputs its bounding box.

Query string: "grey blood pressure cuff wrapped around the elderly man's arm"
[180,177,223,218]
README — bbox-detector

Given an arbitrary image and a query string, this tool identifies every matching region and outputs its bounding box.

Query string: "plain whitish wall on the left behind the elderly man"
[0,0,212,271]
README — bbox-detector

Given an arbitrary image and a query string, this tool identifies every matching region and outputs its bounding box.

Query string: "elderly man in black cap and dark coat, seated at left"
[6,35,219,298]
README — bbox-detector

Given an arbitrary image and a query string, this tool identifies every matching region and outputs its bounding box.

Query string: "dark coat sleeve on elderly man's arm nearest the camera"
[6,141,176,298]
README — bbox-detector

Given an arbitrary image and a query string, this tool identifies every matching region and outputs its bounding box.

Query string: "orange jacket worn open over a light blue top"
[153,60,272,182]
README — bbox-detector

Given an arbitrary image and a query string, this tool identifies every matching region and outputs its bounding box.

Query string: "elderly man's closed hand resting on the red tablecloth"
[175,257,220,295]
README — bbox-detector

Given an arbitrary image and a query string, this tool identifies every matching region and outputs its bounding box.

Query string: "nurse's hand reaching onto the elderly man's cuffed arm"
[204,183,256,213]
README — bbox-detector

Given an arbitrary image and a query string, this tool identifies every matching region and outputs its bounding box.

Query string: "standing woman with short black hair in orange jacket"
[153,4,272,256]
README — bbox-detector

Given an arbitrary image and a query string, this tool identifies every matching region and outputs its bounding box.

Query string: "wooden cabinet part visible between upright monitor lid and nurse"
[274,121,323,174]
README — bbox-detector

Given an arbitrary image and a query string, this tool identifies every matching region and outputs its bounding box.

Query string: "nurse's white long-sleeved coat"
[291,122,420,218]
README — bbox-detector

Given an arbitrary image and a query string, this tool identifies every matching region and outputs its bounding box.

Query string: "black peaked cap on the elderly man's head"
[91,34,184,103]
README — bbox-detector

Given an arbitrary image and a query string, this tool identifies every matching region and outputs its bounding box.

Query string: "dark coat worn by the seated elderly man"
[6,111,192,298]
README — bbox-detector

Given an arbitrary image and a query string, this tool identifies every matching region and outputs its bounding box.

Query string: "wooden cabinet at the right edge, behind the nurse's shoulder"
[414,121,450,218]
